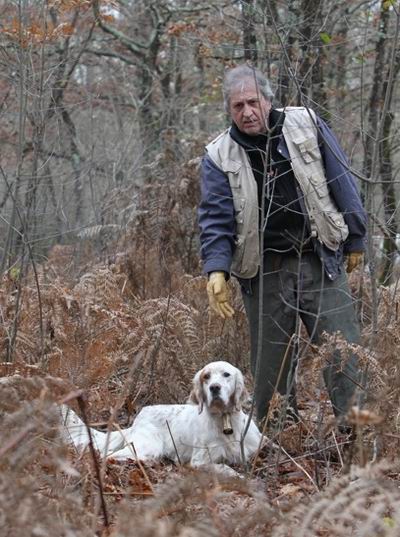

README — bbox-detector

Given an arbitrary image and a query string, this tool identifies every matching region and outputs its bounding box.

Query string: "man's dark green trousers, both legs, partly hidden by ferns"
[241,252,362,421]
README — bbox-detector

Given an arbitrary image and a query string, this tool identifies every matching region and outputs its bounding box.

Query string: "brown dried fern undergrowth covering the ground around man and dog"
[0,163,400,537]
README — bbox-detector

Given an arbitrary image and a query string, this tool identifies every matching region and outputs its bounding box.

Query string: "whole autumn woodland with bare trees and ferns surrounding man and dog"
[0,0,400,537]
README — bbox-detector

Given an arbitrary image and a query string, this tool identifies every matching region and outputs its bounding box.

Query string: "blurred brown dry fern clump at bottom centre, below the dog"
[115,471,280,537]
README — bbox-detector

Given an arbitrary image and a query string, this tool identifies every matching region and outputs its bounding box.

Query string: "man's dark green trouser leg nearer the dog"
[242,255,297,421]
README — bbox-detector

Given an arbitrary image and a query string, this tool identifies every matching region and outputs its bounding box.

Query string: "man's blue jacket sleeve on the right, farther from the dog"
[318,118,367,254]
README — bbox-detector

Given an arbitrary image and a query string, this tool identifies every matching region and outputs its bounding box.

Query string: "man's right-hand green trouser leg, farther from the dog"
[299,254,361,417]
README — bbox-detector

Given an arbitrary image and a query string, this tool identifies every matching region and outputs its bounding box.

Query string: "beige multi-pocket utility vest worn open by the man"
[206,106,349,278]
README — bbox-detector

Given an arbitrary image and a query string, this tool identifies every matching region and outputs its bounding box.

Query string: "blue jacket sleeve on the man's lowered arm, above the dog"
[198,155,235,275]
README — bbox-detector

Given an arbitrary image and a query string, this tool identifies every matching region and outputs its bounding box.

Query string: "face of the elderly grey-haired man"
[229,80,271,136]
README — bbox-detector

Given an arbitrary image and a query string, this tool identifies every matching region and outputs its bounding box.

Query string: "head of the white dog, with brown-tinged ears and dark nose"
[190,361,247,414]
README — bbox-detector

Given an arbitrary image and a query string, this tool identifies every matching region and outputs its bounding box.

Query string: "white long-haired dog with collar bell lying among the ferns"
[58,361,261,466]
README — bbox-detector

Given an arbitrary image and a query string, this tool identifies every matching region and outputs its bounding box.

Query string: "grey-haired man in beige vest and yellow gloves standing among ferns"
[199,65,366,428]
